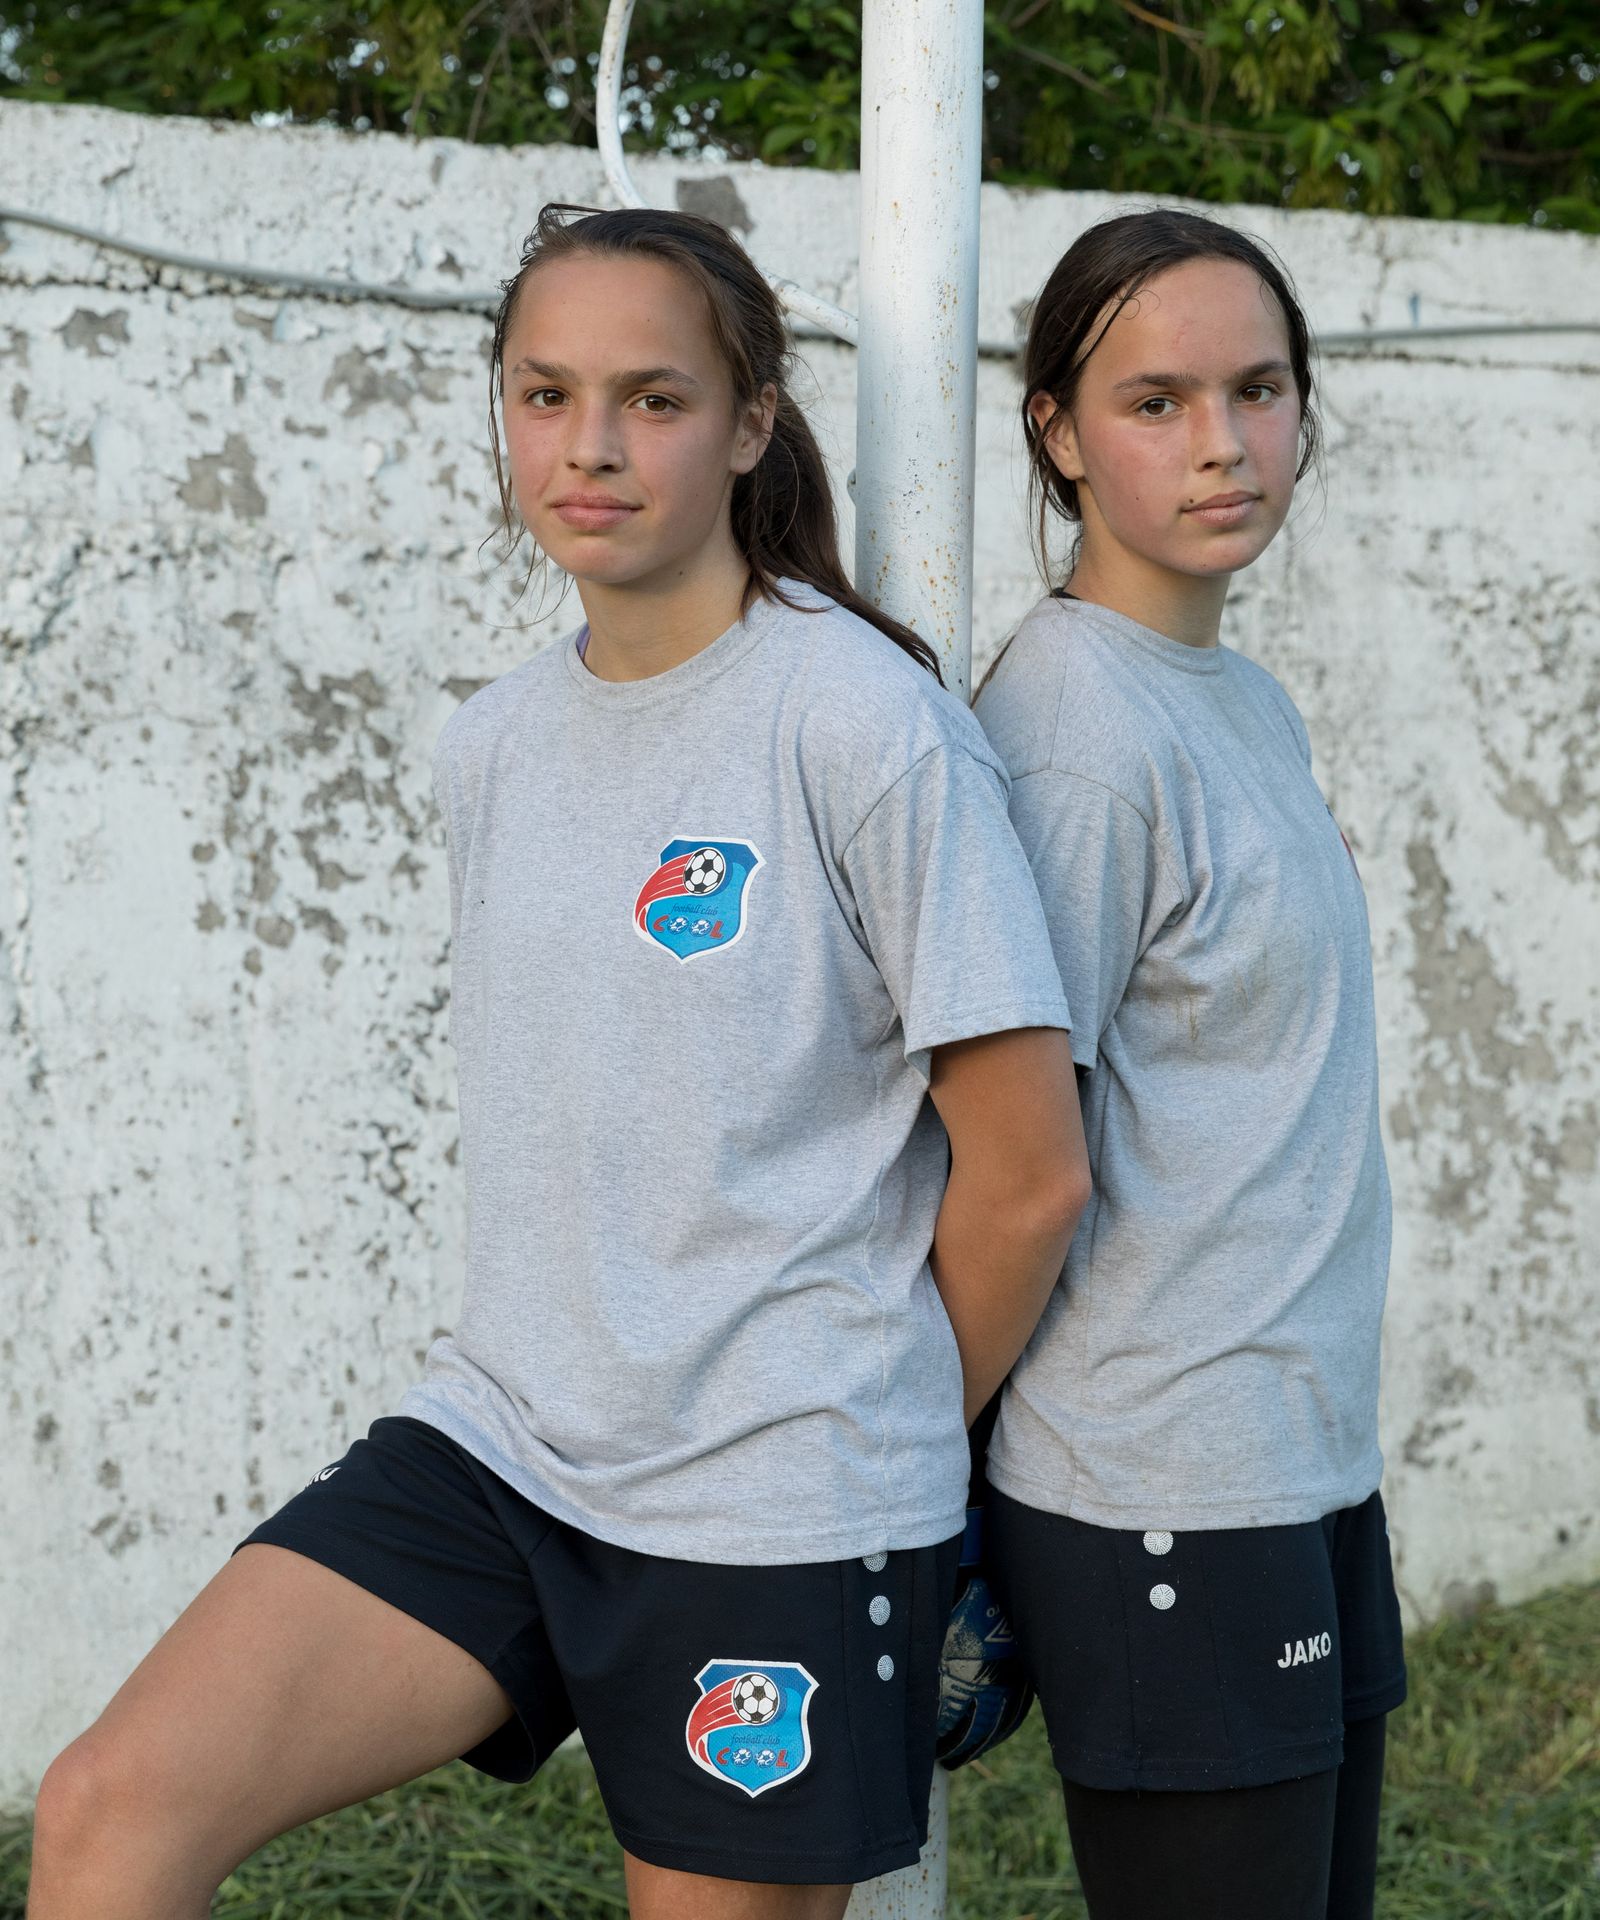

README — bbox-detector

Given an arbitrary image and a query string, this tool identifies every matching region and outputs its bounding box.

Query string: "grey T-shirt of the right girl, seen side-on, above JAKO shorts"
[978,601,1389,1530]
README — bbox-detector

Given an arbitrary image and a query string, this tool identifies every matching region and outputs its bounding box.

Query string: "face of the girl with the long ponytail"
[501,253,772,586]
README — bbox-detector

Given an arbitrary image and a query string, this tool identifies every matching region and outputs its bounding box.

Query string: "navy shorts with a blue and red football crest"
[246,1419,958,1885]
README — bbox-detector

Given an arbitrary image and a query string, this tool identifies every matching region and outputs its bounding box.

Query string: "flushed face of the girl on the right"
[1031,259,1300,578]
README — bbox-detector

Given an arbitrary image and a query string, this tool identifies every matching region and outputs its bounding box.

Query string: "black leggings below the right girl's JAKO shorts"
[1066,1715,1387,1920]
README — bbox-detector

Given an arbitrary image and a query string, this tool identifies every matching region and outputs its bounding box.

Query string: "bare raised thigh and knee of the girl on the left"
[29,1546,511,1920]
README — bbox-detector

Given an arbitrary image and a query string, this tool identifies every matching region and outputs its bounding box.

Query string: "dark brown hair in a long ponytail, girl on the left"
[490,204,941,680]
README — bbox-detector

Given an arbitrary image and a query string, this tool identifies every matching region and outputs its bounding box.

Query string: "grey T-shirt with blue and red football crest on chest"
[401,588,1068,1565]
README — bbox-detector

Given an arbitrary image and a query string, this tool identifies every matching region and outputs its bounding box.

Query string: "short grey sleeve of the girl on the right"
[1010,768,1181,1068]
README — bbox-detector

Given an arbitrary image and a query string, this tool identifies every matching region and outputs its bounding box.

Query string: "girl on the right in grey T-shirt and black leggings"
[978,211,1404,1920]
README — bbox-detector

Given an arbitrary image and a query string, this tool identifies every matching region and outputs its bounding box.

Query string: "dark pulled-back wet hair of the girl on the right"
[1022,207,1321,584]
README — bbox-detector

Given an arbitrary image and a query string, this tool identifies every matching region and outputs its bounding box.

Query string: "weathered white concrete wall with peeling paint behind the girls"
[0,106,1600,1803]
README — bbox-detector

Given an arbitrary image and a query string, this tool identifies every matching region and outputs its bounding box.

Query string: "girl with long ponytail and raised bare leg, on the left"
[31,207,1087,1920]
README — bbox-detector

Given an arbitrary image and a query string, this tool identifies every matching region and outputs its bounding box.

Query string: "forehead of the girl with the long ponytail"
[505,253,718,374]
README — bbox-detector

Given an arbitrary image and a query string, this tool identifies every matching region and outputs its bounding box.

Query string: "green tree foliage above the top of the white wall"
[0,0,1600,230]
